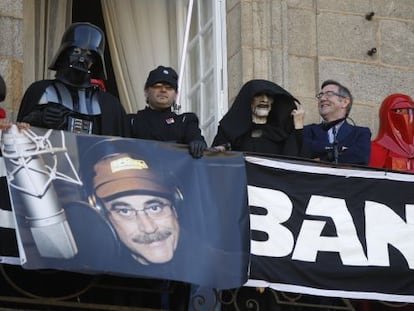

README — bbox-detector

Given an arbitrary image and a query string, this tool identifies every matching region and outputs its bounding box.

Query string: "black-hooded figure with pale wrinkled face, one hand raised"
[212,80,303,156]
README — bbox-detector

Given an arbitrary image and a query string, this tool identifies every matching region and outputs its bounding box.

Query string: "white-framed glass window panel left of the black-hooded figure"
[180,0,227,145]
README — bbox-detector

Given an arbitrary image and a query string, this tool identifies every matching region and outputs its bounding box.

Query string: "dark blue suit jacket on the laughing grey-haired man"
[303,121,371,165]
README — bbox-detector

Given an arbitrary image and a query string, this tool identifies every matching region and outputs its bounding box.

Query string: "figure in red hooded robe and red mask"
[370,94,414,172]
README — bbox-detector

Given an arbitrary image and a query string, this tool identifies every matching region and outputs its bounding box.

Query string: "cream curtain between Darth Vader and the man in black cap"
[102,0,178,112]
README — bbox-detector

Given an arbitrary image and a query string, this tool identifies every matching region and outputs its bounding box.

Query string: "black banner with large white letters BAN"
[246,156,414,302]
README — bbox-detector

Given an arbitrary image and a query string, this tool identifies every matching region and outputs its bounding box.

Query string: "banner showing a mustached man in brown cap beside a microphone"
[2,128,250,289]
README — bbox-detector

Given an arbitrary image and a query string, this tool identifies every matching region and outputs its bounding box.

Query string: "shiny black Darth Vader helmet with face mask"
[49,22,107,80]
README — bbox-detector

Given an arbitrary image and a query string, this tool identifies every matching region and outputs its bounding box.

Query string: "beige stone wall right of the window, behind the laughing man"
[227,0,414,138]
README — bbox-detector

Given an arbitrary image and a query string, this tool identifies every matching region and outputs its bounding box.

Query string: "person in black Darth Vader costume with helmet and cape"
[17,23,128,136]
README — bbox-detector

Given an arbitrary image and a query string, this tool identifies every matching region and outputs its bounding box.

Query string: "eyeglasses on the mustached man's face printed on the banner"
[109,202,172,221]
